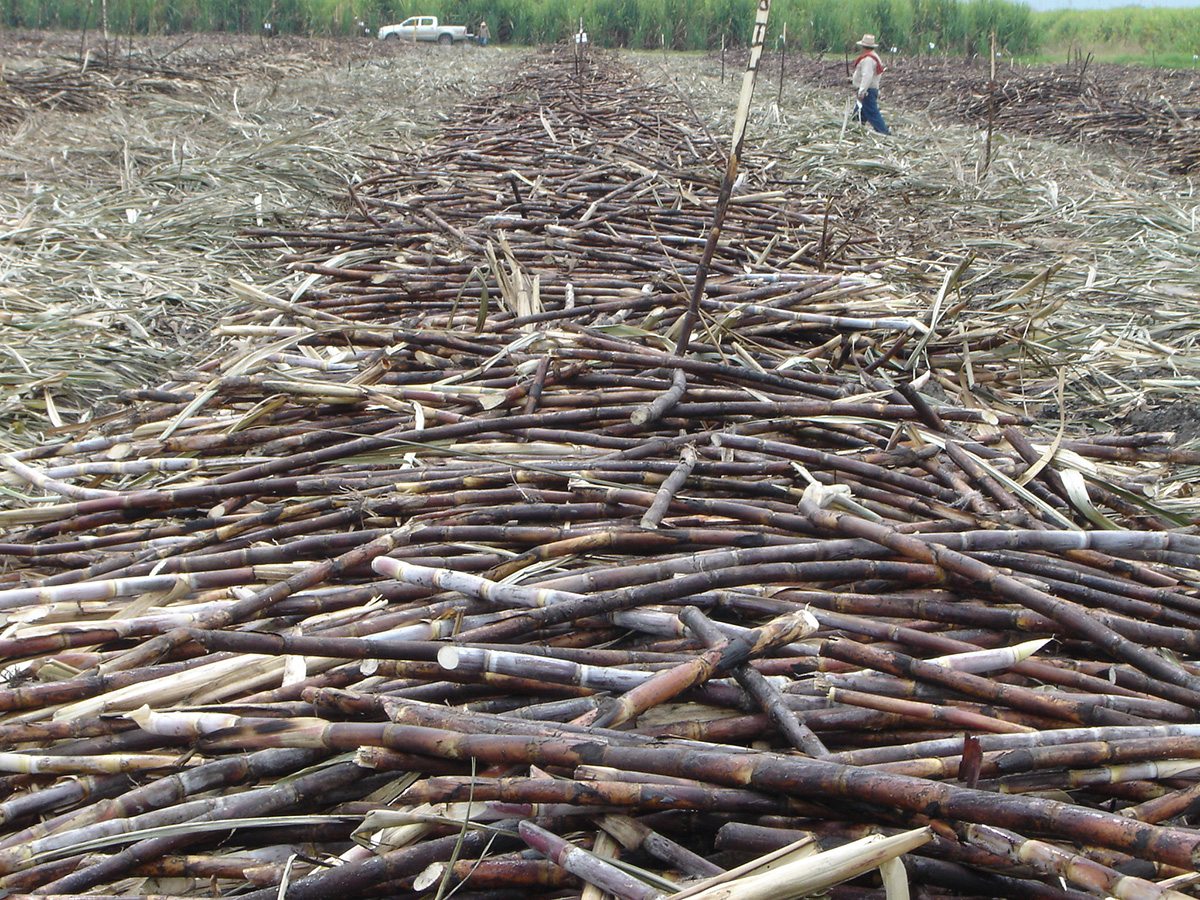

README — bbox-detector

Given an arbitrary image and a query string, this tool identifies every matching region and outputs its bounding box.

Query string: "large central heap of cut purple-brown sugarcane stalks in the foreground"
[0,44,1200,900]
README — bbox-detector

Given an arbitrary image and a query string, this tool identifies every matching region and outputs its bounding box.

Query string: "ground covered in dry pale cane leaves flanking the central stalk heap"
[0,35,1200,445]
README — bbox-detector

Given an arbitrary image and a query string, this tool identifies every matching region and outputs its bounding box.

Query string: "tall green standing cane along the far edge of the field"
[7,0,1200,65]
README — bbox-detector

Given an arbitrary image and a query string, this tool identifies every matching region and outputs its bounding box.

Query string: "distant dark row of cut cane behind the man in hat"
[763,55,1200,174]
